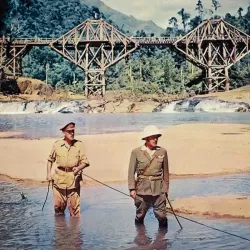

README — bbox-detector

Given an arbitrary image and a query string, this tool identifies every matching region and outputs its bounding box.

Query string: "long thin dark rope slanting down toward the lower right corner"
[83,174,250,241]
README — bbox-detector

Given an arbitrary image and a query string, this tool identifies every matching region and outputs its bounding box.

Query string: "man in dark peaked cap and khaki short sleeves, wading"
[47,122,89,217]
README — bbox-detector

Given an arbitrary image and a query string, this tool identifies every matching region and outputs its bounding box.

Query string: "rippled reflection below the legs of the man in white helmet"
[127,222,168,250]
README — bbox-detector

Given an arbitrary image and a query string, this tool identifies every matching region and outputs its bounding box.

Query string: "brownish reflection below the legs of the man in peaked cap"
[54,216,83,249]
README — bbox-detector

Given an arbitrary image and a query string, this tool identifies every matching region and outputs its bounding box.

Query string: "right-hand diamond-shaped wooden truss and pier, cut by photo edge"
[174,19,250,93]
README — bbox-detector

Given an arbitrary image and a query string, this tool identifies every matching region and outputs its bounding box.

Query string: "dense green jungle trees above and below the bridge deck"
[0,0,250,93]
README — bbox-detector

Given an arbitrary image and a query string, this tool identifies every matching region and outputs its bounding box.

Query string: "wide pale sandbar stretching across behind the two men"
[0,124,250,181]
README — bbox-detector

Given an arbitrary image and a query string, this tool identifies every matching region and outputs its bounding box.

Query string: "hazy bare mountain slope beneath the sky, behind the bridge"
[80,0,164,36]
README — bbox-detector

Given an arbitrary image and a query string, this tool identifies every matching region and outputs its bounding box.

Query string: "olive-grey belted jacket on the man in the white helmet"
[128,145,169,196]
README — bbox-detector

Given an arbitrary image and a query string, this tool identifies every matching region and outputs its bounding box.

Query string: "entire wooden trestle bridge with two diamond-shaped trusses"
[0,19,250,95]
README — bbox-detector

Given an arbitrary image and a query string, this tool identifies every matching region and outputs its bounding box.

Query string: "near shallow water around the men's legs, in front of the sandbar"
[0,174,250,250]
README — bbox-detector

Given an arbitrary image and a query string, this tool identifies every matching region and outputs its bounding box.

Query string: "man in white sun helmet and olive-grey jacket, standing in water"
[128,125,169,227]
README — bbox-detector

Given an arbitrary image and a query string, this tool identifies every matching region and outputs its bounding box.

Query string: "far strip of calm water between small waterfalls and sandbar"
[0,113,250,138]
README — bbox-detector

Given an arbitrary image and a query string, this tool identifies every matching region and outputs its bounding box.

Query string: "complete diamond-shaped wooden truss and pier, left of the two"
[50,19,138,96]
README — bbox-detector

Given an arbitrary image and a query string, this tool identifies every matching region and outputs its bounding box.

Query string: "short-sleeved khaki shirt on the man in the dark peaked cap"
[48,139,89,189]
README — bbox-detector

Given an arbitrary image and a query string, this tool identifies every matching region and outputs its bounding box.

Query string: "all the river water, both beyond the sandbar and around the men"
[0,113,250,250]
